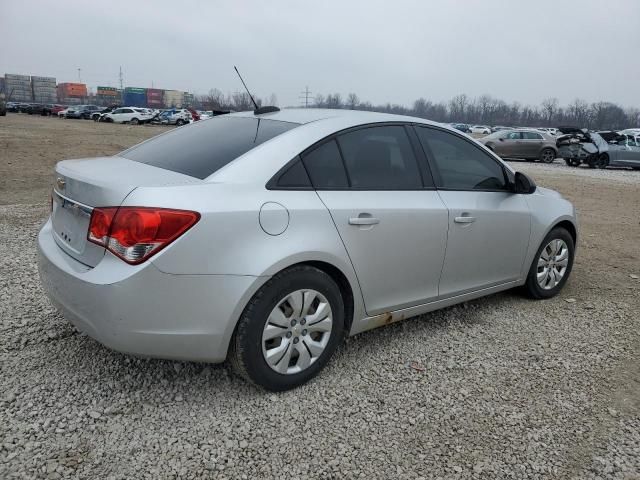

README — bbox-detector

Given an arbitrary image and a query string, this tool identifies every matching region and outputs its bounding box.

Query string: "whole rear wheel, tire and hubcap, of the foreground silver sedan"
[229,265,344,392]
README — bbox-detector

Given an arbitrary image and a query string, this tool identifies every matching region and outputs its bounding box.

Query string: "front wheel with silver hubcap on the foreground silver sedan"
[524,227,575,300]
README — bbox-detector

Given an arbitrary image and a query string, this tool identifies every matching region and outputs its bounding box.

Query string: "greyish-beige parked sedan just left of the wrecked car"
[478,129,558,163]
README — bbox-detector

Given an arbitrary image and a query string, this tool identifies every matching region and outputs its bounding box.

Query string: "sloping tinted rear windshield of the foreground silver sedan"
[120,116,298,179]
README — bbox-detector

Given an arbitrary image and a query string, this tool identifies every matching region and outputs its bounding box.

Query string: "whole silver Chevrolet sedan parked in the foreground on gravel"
[38,109,577,391]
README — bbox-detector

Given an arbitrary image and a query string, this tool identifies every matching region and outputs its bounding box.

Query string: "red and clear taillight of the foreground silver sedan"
[87,207,200,265]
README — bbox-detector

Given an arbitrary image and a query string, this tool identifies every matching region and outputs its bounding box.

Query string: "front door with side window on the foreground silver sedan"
[415,126,531,298]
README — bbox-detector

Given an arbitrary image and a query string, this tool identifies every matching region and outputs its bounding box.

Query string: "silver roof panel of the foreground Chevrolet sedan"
[227,108,446,127]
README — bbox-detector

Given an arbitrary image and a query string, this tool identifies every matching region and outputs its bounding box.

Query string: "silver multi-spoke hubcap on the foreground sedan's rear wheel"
[262,290,333,375]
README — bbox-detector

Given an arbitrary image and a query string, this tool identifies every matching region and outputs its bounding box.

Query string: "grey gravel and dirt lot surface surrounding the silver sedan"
[0,115,640,480]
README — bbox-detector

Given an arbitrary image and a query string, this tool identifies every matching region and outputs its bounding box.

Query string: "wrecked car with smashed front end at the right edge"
[556,127,640,170]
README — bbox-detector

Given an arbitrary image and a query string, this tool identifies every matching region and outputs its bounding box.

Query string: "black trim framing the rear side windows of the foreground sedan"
[265,121,436,192]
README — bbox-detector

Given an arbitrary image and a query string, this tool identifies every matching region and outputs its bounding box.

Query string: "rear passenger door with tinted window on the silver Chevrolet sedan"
[302,124,448,315]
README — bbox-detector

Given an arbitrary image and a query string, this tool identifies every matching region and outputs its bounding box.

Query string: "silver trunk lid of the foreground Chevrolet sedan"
[51,157,202,267]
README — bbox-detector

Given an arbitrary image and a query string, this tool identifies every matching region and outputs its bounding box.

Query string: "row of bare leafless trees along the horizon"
[196,89,640,130]
